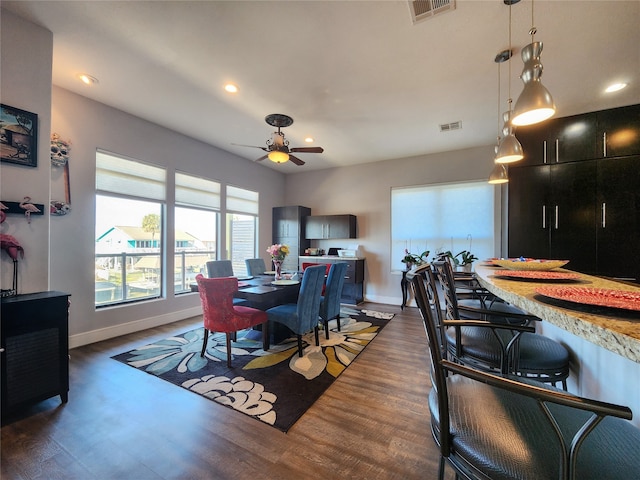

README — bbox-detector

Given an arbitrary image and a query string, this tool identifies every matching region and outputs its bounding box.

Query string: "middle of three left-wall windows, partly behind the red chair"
[174,172,220,293]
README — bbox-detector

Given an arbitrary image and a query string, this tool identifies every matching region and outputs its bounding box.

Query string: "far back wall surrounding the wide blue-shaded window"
[286,146,501,305]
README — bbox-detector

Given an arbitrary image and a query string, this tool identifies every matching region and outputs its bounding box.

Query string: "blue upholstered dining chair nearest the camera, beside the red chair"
[267,265,326,357]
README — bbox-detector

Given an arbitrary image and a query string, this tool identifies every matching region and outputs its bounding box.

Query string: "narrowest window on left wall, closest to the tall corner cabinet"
[226,185,258,275]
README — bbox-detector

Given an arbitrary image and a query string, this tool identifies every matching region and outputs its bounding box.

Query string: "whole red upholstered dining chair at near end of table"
[196,274,269,367]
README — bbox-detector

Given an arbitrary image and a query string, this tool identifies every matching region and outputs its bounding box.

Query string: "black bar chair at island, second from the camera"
[427,262,570,390]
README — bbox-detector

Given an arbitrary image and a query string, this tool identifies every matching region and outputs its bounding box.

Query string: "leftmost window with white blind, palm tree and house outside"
[95,151,166,307]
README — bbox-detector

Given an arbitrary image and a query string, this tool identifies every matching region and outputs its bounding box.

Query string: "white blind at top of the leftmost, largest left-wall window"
[96,151,167,201]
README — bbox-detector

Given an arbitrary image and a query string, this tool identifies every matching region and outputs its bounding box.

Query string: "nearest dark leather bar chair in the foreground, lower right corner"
[410,274,640,480]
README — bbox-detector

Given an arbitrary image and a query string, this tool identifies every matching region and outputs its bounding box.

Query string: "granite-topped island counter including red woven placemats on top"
[474,261,640,427]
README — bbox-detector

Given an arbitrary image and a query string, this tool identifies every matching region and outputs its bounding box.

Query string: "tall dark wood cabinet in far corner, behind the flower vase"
[271,205,311,271]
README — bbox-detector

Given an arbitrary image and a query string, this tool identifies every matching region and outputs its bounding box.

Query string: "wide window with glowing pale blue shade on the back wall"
[391,182,499,270]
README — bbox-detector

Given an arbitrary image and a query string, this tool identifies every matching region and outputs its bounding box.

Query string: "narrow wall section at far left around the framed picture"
[0,10,53,293]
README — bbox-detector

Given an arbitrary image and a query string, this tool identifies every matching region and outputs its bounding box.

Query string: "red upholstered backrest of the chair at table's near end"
[196,274,238,332]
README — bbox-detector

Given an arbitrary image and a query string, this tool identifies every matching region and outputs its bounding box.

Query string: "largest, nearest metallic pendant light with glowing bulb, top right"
[511,0,556,125]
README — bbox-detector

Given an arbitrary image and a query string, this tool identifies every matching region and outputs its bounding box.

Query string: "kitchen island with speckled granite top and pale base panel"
[475,262,640,427]
